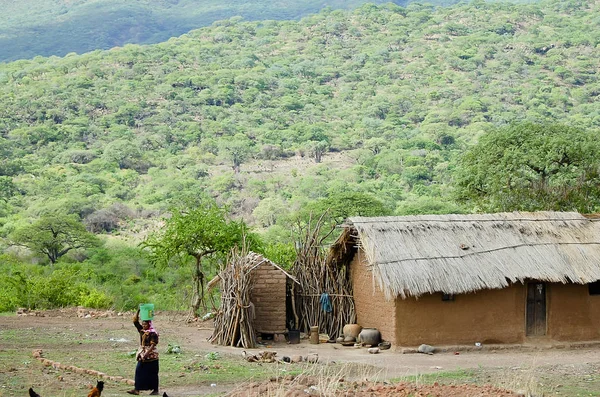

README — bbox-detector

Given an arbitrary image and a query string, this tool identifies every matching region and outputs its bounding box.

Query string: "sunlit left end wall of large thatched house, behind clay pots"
[350,250,396,343]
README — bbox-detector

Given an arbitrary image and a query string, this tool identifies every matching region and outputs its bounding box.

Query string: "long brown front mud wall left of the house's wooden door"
[396,284,525,347]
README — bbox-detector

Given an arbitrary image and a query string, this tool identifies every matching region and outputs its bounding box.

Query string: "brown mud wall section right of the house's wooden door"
[546,284,600,341]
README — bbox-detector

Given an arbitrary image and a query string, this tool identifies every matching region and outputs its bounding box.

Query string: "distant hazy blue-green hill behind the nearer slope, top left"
[0,0,468,62]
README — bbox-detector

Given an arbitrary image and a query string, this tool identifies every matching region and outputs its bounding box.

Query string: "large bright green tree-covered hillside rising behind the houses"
[0,1,600,243]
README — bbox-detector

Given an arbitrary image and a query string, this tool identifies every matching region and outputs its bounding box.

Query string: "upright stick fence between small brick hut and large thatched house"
[292,213,356,338]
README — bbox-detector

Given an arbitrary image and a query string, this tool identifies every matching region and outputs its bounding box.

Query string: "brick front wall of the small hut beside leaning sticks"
[250,263,287,334]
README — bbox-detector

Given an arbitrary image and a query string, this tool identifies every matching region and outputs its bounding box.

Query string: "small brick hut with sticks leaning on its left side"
[208,252,298,348]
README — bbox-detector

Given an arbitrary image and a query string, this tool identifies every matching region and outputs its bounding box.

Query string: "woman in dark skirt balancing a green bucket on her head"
[127,309,158,396]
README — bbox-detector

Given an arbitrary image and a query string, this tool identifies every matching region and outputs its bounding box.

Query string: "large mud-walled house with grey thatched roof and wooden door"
[328,212,600,346]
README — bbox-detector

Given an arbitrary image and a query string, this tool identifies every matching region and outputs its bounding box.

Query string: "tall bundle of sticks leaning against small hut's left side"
[209,249,257,349]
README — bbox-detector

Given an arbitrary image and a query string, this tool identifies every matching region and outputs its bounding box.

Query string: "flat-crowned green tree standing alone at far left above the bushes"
[10,214,100,264]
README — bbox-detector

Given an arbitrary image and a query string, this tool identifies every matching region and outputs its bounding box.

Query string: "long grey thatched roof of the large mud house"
[329,212,600,299]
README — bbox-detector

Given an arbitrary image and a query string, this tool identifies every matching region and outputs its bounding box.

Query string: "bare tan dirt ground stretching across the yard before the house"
[0,310,600,397]
